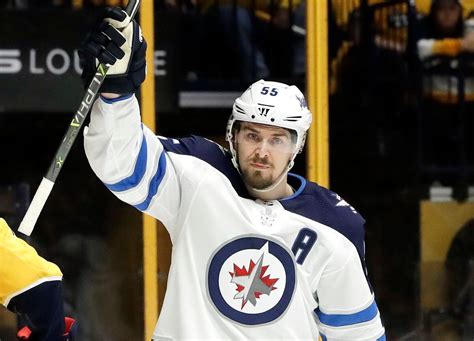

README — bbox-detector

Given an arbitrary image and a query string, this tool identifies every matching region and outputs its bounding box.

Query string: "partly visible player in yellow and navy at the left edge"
[0,218,75,341]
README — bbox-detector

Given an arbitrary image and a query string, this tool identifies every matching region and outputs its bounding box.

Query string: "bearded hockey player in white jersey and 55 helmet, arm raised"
[80,6,385,340]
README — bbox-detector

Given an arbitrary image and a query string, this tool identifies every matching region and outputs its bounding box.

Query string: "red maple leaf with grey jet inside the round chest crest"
[229,254,279,309]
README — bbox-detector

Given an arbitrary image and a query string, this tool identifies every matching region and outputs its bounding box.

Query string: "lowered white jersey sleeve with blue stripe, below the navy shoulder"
[315,247,385,341]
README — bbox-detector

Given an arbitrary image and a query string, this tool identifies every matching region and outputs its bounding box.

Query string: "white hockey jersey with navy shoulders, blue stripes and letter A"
[84,96,385,341]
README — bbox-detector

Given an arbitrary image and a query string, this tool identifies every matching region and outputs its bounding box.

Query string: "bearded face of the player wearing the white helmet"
[234,122,295,189]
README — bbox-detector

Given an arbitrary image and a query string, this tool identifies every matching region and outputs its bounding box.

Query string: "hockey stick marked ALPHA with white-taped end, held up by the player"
[18,0,140,236]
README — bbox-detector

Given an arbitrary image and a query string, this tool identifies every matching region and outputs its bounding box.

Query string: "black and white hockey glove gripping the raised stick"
[79,7,146,94]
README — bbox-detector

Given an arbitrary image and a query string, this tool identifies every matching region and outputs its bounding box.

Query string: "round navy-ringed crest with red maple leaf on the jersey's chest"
[207,235,296,325]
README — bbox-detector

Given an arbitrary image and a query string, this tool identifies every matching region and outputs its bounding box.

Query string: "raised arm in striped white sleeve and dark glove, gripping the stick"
[80,9,180,228]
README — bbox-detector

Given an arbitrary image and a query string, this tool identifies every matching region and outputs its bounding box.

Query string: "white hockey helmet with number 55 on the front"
[226,80,312,170]
